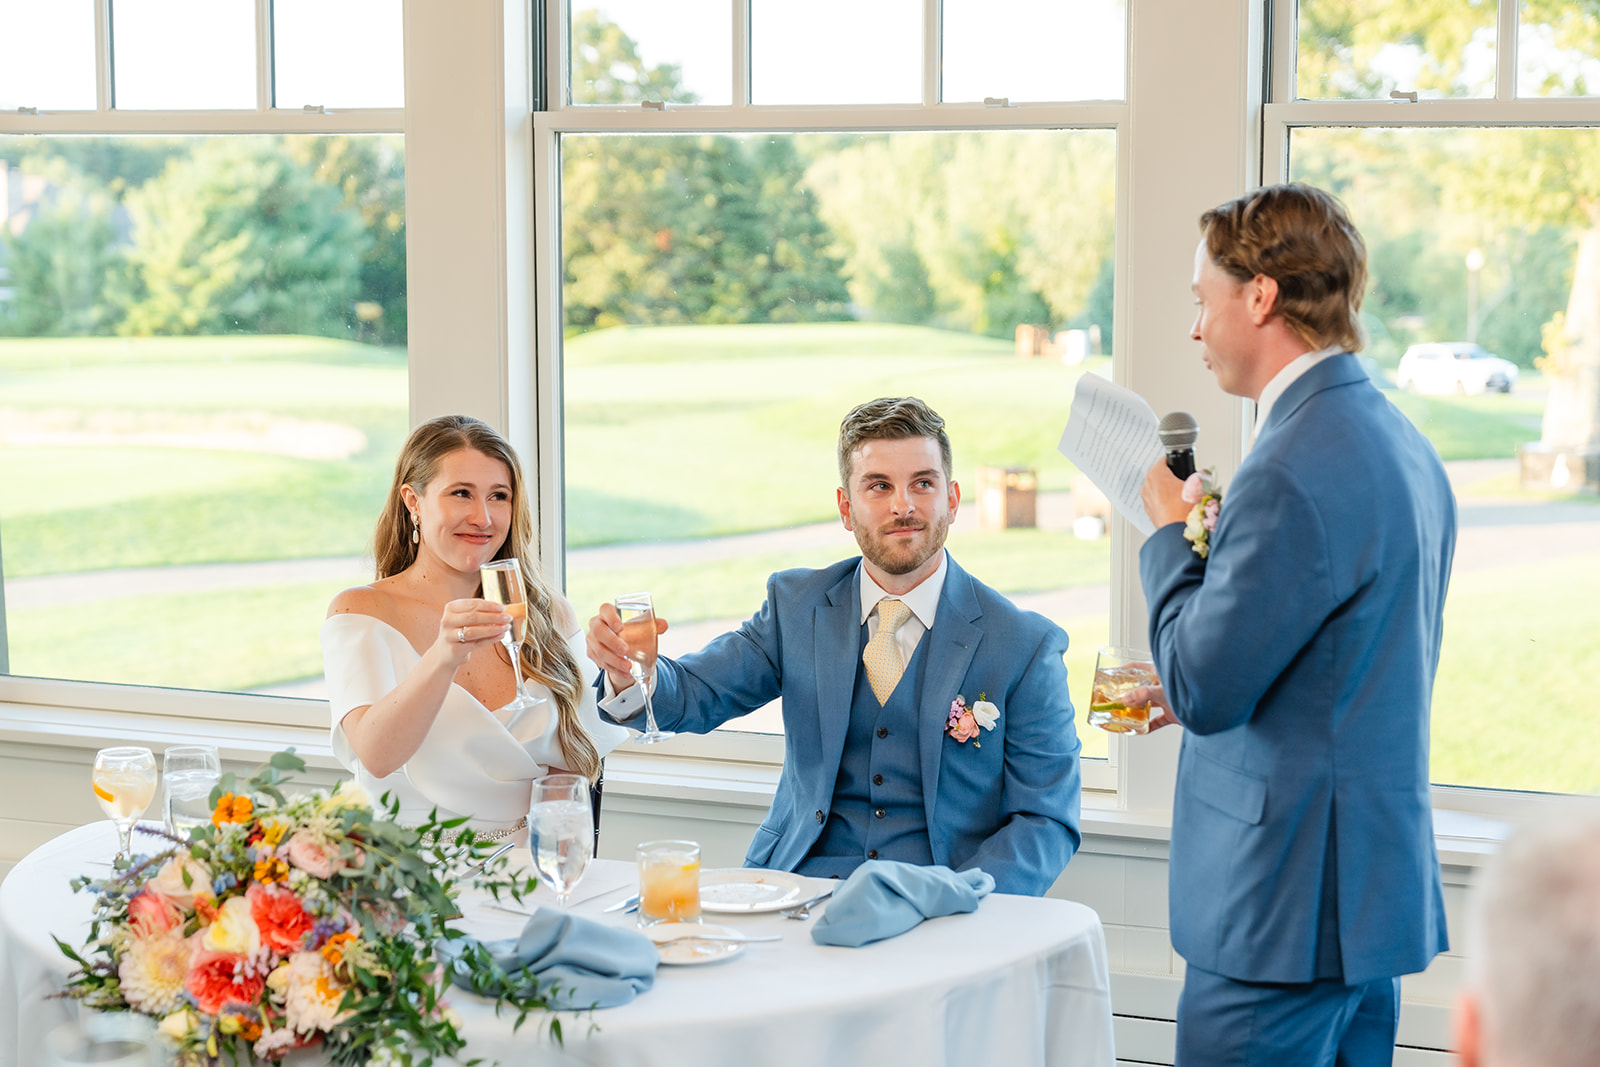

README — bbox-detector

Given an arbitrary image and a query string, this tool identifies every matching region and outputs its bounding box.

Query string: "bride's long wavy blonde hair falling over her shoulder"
[373,414,600,782]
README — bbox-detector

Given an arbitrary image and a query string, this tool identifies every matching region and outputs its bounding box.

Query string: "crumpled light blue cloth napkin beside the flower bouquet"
[442,907,661,1011]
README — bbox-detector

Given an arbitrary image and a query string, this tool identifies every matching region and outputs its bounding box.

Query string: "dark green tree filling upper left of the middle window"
[562,13,846,330]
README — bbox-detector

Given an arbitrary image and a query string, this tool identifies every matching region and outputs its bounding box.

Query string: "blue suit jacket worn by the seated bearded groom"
[617,557,1080,896]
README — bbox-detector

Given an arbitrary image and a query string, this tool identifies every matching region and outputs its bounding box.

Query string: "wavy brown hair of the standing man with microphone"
[1200,182,1366,352]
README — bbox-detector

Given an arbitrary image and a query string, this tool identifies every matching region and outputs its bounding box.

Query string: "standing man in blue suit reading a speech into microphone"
[1139,186,1456,1067]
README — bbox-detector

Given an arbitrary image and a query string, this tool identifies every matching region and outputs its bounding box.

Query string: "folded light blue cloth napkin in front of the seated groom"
[811,859,995,949]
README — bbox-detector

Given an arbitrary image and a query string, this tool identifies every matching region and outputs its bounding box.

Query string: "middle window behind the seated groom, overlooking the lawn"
[538,0,1125,783]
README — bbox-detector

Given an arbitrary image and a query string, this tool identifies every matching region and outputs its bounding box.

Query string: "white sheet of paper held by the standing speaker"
[1056,374,1163,537]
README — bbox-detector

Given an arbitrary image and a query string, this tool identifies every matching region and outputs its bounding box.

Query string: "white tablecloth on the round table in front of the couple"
[0,822,1114,1067]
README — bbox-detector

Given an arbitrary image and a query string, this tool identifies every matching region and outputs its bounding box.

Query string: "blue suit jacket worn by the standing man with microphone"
[1139,354,1456,984]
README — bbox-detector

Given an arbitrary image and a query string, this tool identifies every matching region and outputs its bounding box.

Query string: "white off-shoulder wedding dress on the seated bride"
[322,613,627,843]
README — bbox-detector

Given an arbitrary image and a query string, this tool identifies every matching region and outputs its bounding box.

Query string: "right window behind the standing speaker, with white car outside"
[1267,0,1600,792]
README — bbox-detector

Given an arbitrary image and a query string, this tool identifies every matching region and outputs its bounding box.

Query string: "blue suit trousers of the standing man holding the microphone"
[1178,966,1400,1067]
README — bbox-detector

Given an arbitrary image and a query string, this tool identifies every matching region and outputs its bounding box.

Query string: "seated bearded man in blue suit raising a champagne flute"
[589,398,1080,896]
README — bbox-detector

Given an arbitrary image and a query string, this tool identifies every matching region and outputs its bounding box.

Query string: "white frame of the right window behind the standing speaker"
[1261,0,1600,835]
